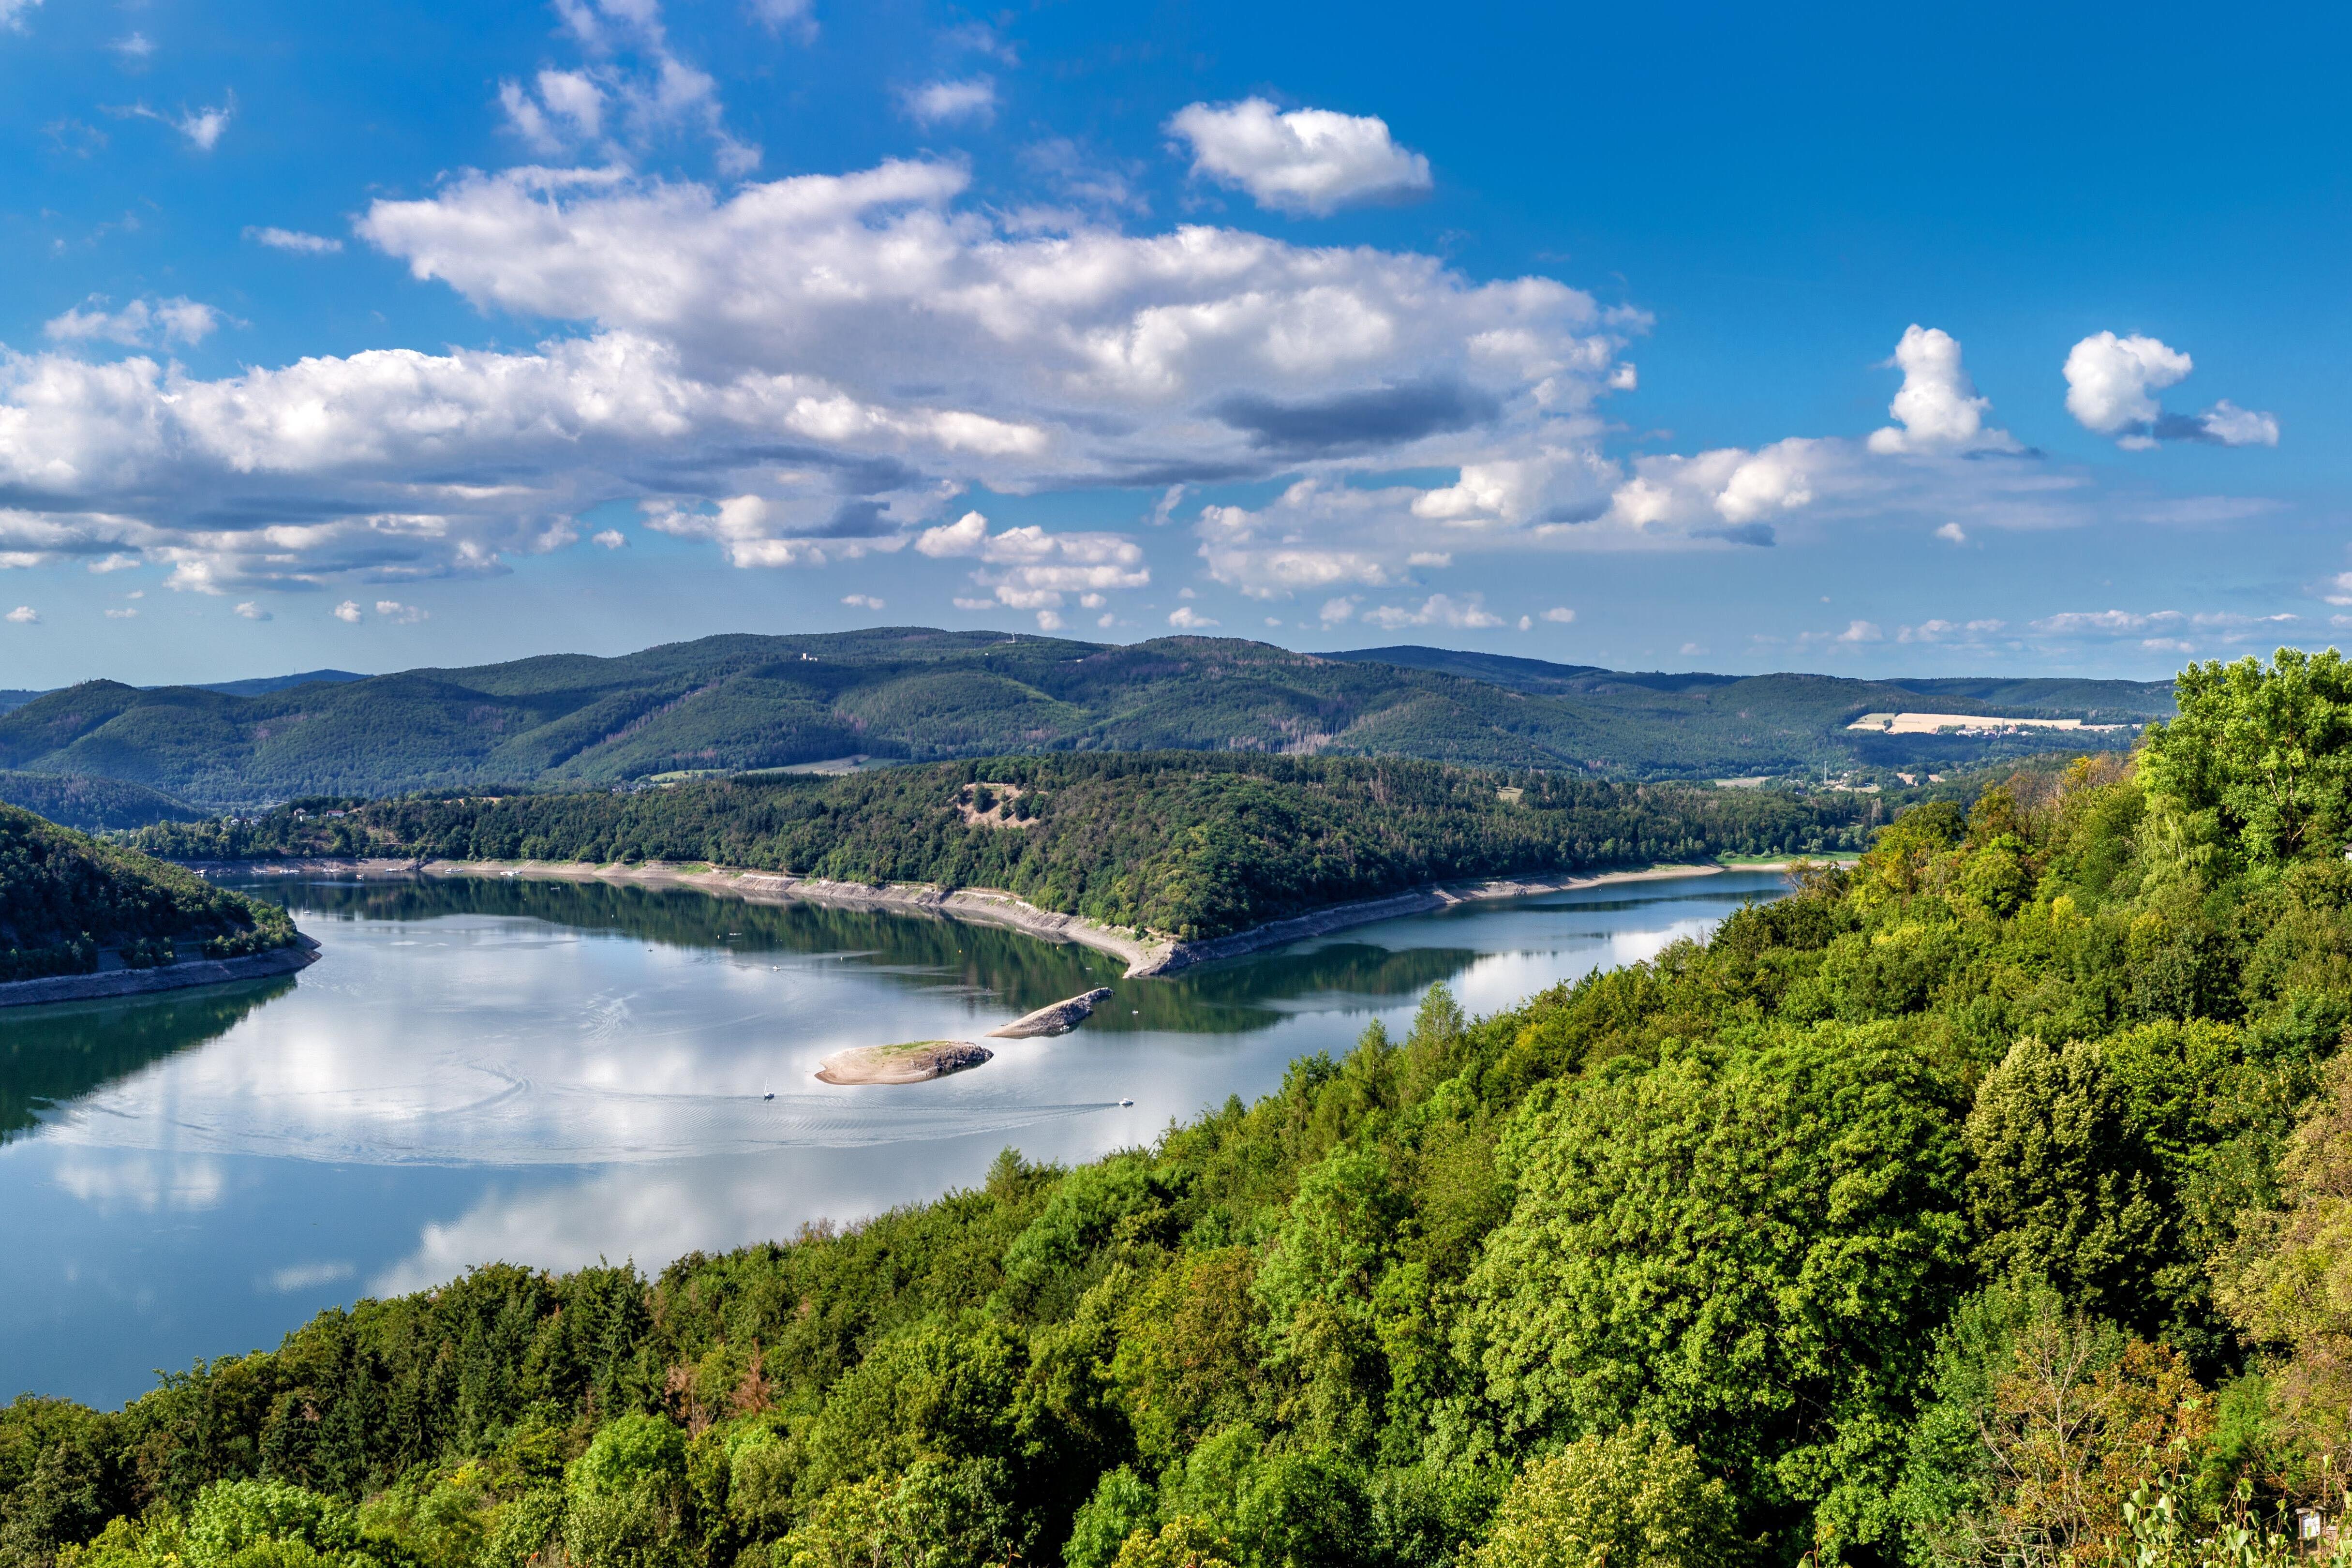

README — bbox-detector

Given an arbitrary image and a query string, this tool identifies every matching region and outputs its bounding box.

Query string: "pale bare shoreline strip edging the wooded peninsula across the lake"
[188,858,1795,980]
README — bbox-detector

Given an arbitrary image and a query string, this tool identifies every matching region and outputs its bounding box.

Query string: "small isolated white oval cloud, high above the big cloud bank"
[1169,99,1430,216]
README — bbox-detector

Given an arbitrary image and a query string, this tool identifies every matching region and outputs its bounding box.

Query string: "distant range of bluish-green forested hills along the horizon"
[0,627,2169,804]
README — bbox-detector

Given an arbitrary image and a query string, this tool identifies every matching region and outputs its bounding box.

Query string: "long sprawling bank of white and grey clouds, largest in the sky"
[18,138,2218,613]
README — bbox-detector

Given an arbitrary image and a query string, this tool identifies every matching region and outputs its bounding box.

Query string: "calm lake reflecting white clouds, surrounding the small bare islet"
[0,872,1783,1404]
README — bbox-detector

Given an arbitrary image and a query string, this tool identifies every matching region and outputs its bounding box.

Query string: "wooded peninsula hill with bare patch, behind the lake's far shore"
[132,752,1879,938]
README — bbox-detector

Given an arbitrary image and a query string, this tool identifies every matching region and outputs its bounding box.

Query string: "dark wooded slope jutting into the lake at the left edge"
[0,806,294,980]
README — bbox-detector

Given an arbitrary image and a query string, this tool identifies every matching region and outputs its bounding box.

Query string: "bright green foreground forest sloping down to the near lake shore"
[0,651,2352,1568]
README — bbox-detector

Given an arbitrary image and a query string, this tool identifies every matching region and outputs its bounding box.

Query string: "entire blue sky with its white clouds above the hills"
[0,0,2352,687]
